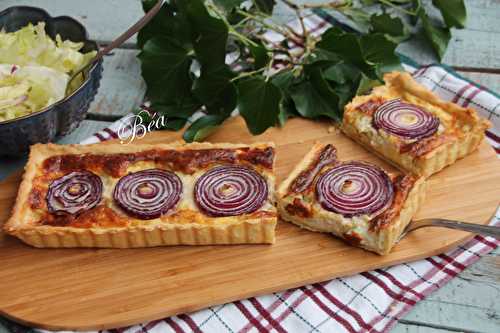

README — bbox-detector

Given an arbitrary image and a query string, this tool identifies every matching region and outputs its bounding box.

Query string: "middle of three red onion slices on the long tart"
[113,169,182,220]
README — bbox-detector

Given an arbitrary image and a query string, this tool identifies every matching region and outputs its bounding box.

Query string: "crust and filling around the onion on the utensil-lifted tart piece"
[277,144,426,255]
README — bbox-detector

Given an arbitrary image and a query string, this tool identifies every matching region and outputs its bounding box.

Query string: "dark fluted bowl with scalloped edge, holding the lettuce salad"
[0,6,102,156]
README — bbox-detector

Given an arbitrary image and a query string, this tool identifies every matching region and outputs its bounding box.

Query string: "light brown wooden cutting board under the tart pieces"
[0,118,500,330]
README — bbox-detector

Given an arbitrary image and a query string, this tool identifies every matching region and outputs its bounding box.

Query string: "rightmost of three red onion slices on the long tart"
[194,166,268,217]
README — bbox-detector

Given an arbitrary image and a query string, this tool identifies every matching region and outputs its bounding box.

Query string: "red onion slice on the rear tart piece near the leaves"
[373,99,439,139]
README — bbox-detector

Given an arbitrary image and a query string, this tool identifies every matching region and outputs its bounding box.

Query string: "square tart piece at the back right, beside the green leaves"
[342,72,490,177]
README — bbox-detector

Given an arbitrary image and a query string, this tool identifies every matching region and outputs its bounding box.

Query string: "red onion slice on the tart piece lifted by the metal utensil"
[316,162,394,217]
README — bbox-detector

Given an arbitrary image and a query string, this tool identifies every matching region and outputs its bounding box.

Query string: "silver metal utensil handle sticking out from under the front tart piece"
[398,219,500,241]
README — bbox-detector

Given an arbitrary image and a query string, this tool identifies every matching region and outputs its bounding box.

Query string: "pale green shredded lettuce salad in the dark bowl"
[0,22,96,121]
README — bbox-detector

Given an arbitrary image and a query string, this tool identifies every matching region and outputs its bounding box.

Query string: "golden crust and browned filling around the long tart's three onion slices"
[4,142,277,248]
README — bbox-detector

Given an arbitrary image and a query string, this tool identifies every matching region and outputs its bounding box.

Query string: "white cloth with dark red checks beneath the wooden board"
[5,11,500,333]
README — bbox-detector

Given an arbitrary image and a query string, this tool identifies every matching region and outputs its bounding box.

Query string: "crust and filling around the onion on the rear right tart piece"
[342,72,490,177]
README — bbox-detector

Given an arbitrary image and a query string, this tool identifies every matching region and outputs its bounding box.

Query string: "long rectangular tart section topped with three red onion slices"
[4,143,277,248]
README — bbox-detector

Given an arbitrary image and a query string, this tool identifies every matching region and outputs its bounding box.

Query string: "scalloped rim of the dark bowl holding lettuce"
[0,6,102,126]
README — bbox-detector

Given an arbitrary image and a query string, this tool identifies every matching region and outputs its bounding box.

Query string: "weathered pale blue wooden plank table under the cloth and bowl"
[0,0,500,333]
